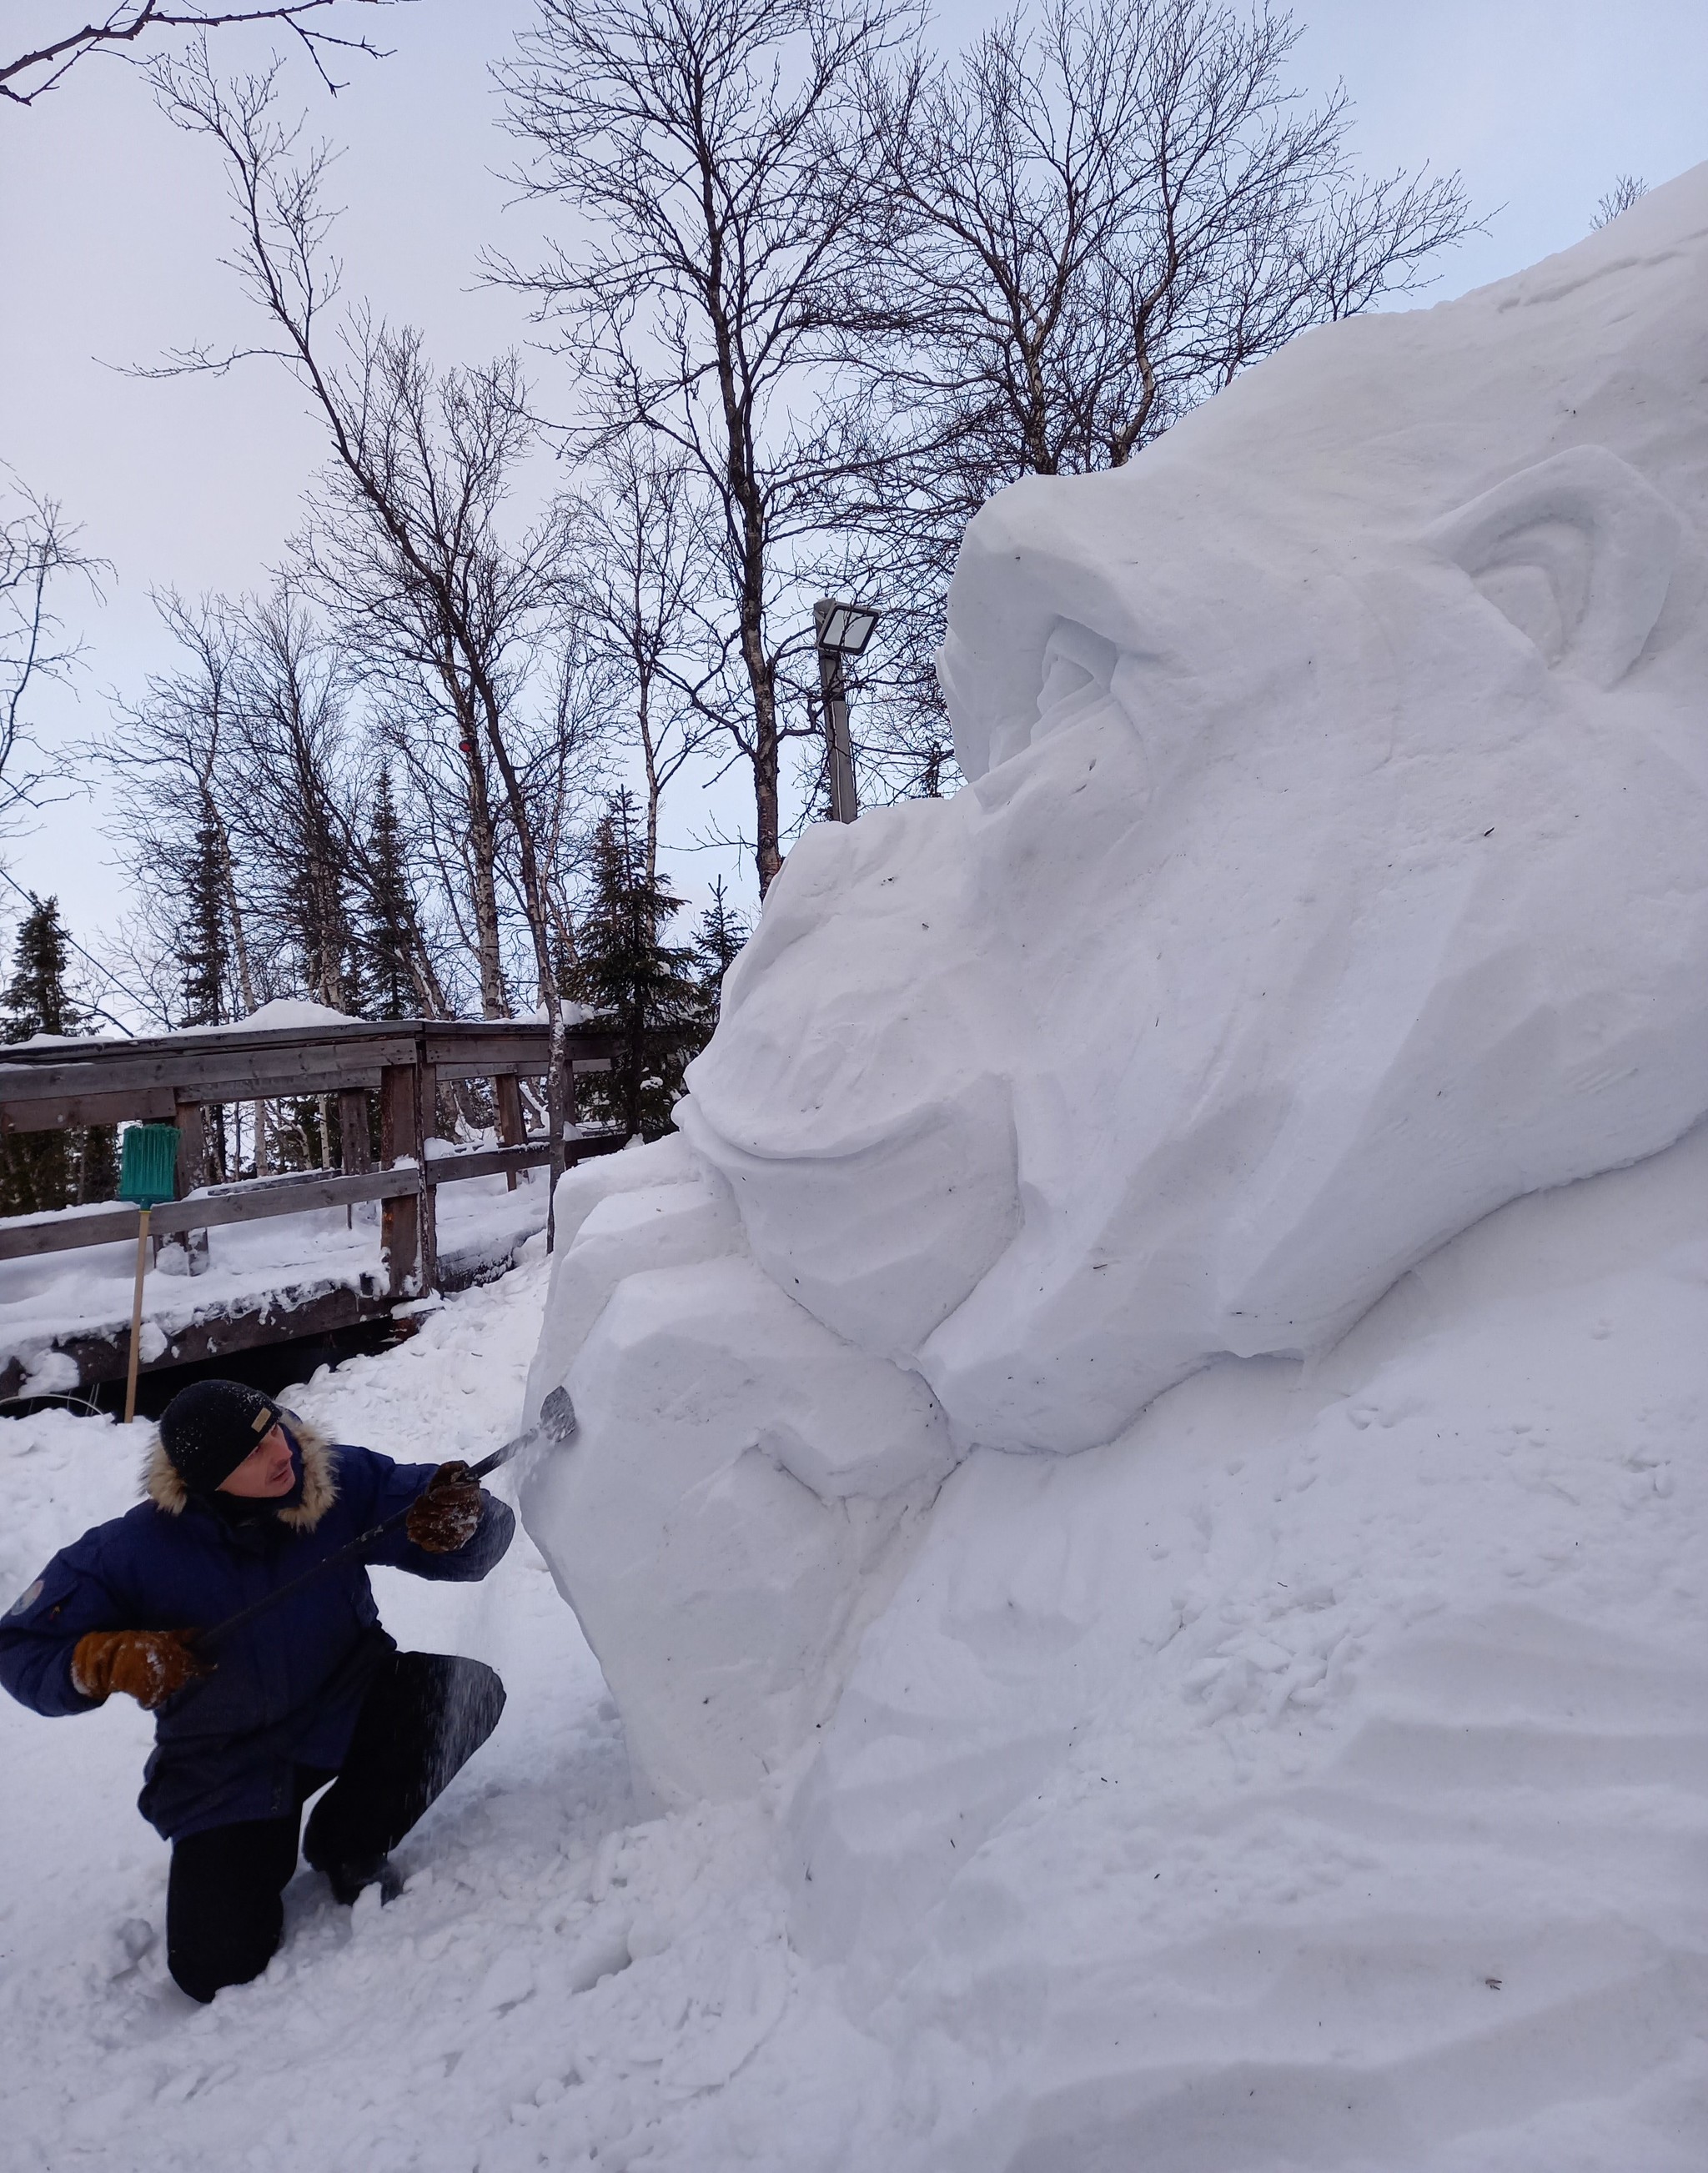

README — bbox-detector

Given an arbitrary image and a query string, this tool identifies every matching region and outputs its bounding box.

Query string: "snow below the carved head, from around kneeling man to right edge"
[0,1134,1708,2173]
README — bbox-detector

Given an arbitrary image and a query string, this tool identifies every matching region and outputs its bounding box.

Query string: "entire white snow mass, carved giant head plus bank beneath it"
[524,168,1708,2173]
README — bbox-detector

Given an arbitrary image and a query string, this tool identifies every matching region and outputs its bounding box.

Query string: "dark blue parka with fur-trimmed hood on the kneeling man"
[0,1419,515,1840]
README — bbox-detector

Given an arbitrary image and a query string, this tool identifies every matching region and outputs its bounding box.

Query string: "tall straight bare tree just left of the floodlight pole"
[495,0,893,891]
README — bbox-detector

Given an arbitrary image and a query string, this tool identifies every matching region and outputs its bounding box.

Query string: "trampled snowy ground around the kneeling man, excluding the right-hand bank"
[0,1265,858,2173]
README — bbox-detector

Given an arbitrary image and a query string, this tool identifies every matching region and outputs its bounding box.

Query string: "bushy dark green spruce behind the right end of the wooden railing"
[570,789,704,1139]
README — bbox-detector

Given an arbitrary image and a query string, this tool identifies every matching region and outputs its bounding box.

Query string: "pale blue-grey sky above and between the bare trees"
[0,0,1708,995]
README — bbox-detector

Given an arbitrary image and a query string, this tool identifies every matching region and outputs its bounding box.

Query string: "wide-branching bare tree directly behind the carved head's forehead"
[830,0,1471,789]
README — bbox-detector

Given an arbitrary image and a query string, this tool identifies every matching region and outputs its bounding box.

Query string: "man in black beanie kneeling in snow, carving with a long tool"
[0,1380,515,2001]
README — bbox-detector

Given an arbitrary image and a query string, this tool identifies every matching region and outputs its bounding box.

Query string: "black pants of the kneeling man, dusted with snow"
[165,1652,504,2001]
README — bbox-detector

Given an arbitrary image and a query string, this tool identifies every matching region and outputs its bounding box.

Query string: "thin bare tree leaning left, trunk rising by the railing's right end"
[154,48,600,1238]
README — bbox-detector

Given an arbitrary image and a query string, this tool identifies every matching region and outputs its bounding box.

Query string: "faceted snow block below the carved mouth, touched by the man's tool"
[521,1242,954,1806]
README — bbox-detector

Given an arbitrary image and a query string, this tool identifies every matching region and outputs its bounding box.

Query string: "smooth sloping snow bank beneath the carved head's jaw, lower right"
[789,1130,1708,2173]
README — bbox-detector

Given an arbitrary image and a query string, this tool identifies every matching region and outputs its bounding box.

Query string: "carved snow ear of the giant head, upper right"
[1428,445,1682,686]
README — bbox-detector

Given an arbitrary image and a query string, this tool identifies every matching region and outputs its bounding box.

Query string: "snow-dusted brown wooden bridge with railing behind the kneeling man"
[0,1019,624,1402]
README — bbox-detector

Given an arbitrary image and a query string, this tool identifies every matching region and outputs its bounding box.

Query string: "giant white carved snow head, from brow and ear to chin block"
[524,169,1708,1797]
